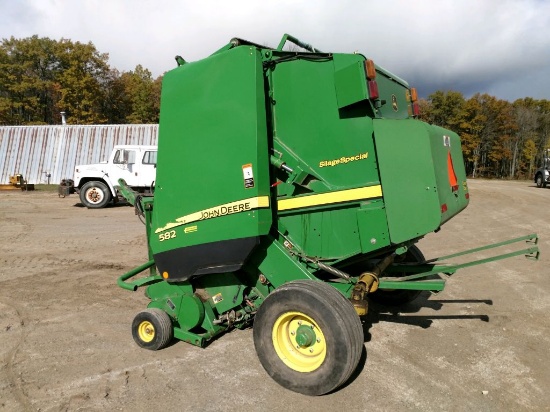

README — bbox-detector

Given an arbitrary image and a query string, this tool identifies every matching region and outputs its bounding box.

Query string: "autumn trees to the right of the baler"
[420,91,550,179]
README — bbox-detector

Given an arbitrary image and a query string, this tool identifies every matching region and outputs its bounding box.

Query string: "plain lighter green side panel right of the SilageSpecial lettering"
[373,119,441,244]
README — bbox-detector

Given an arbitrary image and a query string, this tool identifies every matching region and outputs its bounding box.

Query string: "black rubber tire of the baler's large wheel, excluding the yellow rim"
[253,280,364,395]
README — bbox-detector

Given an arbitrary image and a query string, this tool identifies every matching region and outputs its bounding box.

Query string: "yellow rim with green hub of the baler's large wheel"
[272,312,327,372]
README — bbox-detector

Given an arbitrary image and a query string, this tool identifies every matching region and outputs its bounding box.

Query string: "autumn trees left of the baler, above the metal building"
[0,35,161,125]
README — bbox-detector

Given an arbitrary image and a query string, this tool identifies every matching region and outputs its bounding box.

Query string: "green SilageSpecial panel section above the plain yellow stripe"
[271,55,379,192]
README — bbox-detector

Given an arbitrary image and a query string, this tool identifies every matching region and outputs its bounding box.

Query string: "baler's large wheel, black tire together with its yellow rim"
[253,280,364,395]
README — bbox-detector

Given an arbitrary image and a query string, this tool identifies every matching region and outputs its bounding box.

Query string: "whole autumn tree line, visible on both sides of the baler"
[0,35,550,178]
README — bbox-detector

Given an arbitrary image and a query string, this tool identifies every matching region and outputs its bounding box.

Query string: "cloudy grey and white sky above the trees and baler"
[0,0,550,101]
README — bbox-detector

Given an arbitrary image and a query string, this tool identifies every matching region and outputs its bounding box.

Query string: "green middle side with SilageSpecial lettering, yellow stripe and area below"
[271,51,387,259]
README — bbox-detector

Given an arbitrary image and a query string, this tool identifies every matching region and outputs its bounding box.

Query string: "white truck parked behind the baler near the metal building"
[74,145,157,209]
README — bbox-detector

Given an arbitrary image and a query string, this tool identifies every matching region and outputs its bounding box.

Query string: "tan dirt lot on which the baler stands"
[0,181,550,411]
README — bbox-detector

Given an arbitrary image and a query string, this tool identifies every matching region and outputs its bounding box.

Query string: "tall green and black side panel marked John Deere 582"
[150,46,272,280]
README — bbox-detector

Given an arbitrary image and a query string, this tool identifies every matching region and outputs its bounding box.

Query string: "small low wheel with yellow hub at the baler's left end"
[132,308,174,350]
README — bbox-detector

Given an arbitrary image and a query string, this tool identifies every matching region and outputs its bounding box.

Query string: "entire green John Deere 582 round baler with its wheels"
[119,35,538,395]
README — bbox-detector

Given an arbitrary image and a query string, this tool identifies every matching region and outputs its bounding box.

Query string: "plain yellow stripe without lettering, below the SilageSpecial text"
[277,185,382,211]
